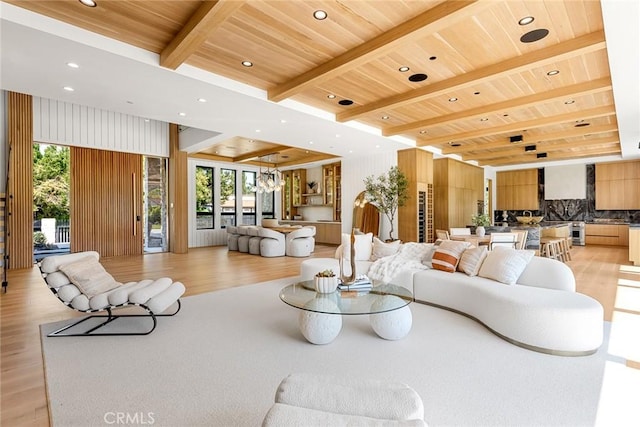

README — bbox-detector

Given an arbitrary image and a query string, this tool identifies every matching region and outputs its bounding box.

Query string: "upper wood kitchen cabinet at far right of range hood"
[595,160,640,210]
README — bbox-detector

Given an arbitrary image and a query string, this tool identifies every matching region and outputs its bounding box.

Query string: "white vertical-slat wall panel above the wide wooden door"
[33,97,169,157]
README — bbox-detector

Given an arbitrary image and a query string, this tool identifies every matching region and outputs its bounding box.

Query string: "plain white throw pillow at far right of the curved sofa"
[478,246,535,285]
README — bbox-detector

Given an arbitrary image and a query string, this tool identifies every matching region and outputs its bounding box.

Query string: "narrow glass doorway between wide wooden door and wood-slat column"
[142,156,169,253]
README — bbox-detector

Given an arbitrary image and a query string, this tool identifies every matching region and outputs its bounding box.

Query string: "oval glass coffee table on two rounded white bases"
[280,280,413,344]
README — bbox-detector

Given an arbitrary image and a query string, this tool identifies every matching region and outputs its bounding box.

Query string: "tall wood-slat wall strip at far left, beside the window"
[7,92,33,269]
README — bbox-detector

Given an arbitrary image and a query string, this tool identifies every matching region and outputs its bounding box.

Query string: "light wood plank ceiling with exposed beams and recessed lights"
[8,0,621,166]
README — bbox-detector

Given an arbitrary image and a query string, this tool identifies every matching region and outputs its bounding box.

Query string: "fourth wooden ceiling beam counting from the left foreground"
[382,77,611,136]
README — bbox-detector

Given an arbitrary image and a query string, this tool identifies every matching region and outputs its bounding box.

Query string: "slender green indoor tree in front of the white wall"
[364,166,409,240]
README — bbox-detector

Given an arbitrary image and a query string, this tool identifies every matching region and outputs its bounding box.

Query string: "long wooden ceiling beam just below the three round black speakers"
[336,31,606,122]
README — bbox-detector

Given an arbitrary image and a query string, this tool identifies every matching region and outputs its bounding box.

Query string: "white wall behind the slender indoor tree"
[342,152,398,241]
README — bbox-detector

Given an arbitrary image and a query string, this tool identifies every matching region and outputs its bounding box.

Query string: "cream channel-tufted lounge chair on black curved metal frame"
[38,251,185,337]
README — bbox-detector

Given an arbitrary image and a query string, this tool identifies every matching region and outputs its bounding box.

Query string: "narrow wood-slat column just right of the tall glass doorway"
[169,123,189,254]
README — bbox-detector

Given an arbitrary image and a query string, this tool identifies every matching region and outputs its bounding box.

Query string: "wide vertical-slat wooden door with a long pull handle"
[70,147,142,257]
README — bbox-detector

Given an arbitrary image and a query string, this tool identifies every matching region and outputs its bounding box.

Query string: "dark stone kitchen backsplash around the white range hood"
[494,164,640,224]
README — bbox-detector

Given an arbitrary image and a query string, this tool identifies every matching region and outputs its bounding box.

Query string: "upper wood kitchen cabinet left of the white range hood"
[496,169,540,211]
